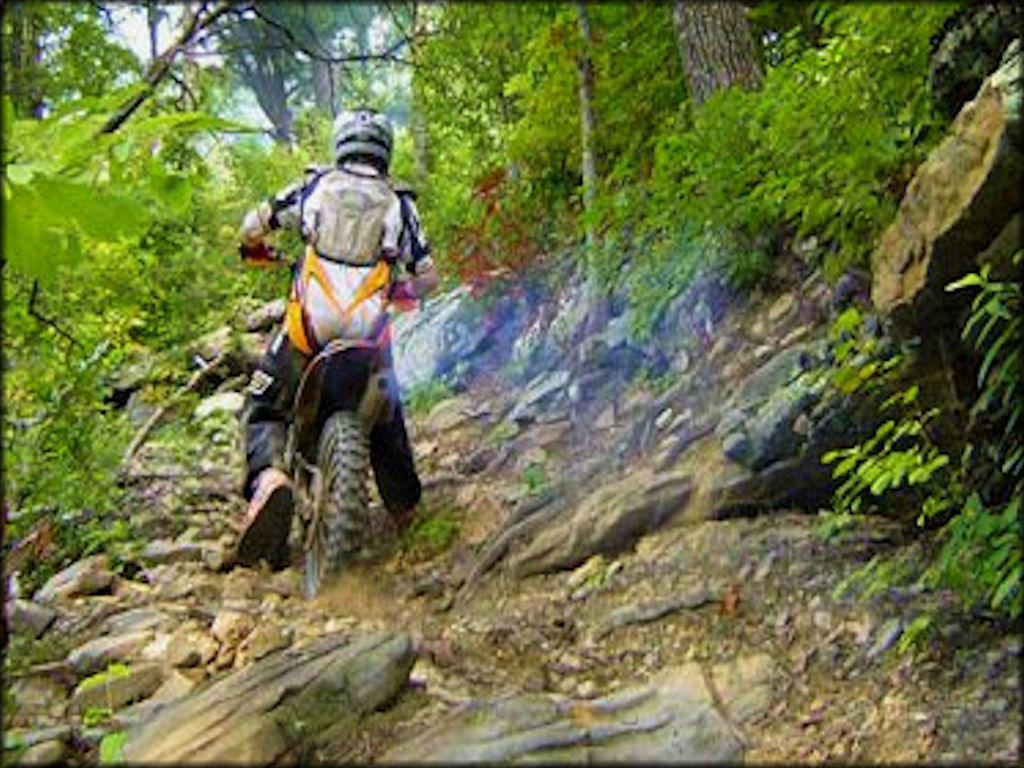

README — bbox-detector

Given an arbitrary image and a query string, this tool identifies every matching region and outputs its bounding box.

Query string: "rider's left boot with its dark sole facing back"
[238,467,295,569]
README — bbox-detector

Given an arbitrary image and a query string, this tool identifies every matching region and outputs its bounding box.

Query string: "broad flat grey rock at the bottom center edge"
[381,665,743,763]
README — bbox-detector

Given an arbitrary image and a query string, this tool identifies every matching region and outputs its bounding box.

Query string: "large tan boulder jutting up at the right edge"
[871,39,1024,335]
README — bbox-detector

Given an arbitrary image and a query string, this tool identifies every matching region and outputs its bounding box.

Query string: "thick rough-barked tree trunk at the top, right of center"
[672,0,762,104]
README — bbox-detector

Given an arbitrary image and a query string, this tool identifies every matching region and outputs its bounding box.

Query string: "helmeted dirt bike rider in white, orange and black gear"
[238,109,437,569]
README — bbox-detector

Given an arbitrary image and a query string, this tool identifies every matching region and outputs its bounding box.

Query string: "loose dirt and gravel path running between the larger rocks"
[4,362,1021,762]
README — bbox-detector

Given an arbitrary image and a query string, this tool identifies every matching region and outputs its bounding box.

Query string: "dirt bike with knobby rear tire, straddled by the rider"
[285,339,396,598]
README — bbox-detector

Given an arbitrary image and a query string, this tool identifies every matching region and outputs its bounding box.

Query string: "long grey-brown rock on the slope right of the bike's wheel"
[511,469,692,575]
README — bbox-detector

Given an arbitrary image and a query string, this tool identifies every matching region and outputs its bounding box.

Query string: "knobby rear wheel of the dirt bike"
[305,411,370,598]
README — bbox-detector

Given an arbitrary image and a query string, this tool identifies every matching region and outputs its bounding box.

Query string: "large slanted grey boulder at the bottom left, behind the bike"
[124,633,415,764]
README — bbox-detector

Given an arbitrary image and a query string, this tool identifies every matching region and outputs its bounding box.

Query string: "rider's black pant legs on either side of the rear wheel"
[242,329,421,514]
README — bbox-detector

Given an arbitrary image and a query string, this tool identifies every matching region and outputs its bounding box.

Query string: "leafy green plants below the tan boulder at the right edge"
[822,252,1024,626]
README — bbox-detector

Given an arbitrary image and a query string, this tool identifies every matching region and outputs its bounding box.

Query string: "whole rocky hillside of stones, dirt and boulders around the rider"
[4,34,1021,764]
